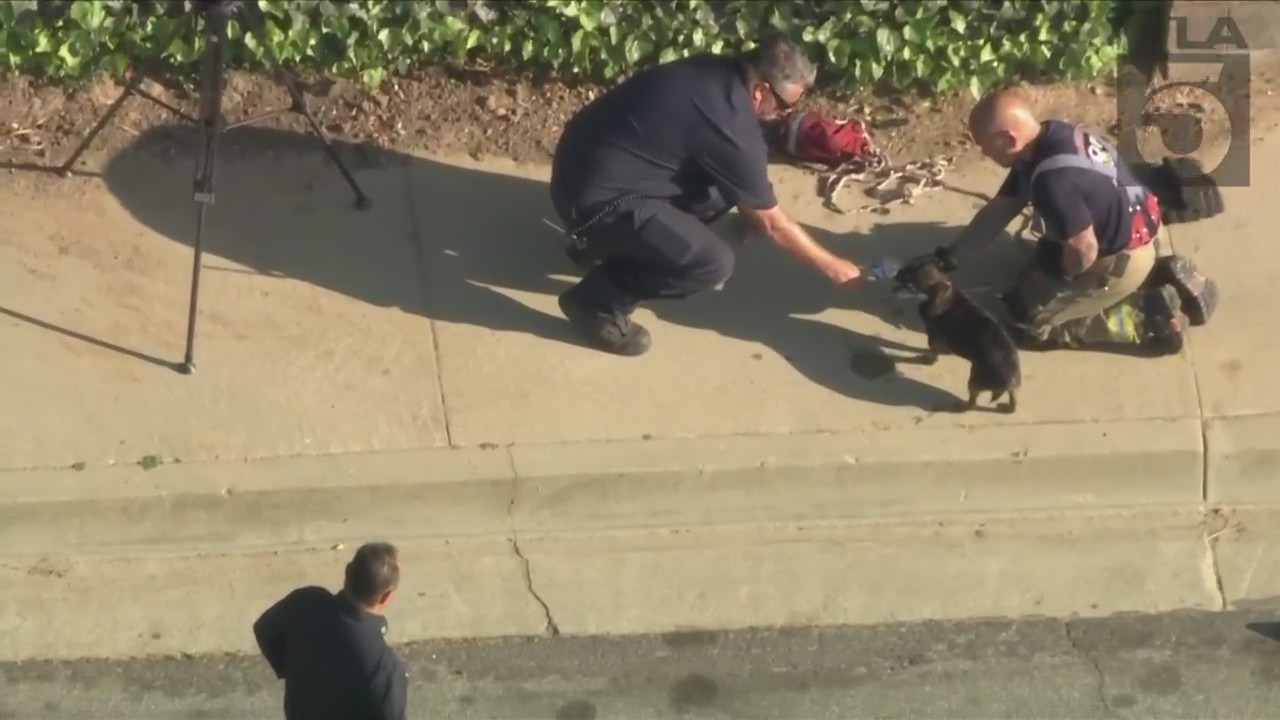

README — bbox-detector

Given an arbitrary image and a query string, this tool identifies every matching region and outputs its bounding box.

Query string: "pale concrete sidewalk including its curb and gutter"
[0,116,1280,659]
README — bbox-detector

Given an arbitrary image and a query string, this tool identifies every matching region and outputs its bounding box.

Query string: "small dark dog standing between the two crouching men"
[893,250,1023,413]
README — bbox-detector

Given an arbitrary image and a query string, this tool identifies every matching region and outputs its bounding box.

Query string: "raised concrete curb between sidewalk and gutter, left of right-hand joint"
[0,419,1204,556]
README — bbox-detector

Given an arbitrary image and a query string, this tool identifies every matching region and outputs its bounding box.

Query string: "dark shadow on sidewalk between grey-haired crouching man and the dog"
[652,214,1034,413]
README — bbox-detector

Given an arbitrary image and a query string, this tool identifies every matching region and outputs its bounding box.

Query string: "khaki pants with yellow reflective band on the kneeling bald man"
[1018,228,1169,346]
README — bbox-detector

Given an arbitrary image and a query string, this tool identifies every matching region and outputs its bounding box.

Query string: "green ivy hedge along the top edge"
[0,0,1137,94]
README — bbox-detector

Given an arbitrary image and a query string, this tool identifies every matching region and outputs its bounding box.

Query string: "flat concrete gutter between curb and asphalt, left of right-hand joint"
[0,509,1221,660]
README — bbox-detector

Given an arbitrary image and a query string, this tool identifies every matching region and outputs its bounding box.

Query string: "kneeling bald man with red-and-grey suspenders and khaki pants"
[950,87,1217,355]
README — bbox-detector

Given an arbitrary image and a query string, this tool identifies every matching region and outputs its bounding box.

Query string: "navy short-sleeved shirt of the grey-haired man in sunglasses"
[552,55,778,210]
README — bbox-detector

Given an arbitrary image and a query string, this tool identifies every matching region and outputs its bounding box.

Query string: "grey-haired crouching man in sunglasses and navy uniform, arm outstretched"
[550,36,860,356]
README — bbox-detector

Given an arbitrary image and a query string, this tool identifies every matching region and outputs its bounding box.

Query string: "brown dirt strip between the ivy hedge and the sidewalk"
[0,53,1280,188]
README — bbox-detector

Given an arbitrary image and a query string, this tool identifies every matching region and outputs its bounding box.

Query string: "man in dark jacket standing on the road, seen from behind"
[253,542,408,720]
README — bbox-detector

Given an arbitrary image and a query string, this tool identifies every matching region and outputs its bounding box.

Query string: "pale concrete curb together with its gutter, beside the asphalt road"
[10,416,1280,660]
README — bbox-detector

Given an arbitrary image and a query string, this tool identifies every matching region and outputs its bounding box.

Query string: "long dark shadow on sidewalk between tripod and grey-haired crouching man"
[104,126,577,343]
